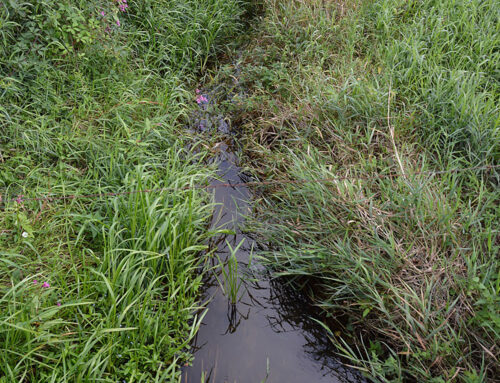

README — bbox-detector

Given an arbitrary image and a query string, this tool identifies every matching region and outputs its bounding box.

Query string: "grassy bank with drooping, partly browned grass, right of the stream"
[226,0,500,382]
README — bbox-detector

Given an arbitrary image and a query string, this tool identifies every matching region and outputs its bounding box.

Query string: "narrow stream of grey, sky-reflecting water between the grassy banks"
[182,87,364,383]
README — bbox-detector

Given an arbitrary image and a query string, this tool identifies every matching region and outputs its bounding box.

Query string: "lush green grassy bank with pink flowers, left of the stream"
[0,0,248,382]
